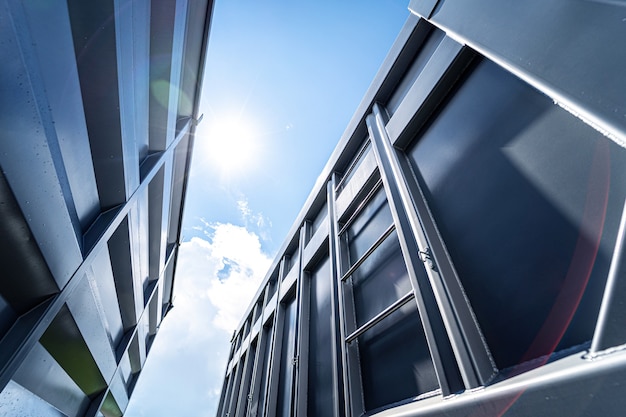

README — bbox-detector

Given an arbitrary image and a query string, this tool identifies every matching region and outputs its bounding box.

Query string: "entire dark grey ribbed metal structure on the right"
[218,0,626,417]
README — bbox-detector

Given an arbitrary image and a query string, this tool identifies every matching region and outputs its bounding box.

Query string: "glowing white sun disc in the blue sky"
[204,116,260,176]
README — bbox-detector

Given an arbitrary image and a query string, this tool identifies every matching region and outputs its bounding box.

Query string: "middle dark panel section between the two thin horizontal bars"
[351,231,411,327]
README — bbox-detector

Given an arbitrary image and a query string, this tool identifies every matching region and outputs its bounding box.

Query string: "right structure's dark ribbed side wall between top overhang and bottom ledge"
[221,14,626,417]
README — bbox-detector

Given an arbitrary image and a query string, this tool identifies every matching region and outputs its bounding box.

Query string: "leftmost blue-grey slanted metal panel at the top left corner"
[0,2,82,287]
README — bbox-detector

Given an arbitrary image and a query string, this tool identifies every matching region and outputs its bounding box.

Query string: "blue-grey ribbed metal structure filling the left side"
[0,0,213,417]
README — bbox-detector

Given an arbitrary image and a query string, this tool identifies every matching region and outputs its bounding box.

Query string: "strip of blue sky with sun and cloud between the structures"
[125,0,409,417]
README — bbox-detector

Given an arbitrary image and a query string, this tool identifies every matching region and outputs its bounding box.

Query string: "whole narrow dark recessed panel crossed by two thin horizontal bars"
[342,184,438,411]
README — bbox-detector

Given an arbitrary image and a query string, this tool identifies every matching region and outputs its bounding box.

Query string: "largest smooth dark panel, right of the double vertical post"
[408,57,626,368]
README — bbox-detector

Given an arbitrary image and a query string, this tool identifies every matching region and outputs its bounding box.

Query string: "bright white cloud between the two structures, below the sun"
[125,220,271,417]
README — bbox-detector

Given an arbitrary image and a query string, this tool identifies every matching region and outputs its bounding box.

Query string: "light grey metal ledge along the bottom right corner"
[366,352,626,417]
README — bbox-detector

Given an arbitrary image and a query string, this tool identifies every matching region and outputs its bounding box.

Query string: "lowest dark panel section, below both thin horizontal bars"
[358,302,439,411]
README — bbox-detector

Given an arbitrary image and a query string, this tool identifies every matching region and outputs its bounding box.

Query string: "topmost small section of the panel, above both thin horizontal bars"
[346,188,393,265]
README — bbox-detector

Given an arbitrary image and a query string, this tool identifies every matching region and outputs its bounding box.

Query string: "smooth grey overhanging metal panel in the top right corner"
[422,0,626,146]
